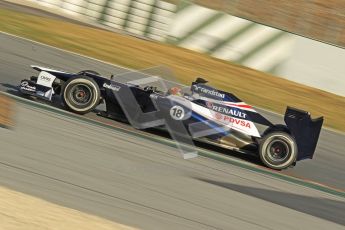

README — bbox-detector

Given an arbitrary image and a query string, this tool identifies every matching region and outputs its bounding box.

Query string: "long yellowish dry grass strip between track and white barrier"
[0,9,345,131]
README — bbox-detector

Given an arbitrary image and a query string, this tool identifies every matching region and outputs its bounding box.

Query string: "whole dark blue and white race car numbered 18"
[19,66,323,170]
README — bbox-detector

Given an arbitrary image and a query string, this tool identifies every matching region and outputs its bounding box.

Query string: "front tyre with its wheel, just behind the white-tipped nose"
[61,76,100,114]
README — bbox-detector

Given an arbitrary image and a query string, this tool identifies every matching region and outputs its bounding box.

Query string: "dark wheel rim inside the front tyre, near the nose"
[69,84,92,106]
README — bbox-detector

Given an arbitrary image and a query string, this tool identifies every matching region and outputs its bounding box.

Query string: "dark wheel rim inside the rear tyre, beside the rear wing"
[266,139,291,163]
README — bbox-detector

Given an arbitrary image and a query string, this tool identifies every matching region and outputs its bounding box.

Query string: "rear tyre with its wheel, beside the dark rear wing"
[259,132,298,170]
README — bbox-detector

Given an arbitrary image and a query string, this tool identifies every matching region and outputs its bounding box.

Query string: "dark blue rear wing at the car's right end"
[284,107,323,160]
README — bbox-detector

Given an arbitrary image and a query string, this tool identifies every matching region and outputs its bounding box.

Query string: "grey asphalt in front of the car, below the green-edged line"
[0,97,345,230]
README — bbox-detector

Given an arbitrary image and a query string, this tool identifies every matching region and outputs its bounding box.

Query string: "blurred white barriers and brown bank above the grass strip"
[12,0,345,96]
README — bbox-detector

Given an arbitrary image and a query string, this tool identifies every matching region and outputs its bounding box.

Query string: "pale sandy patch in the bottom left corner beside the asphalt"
[0,187,134,230]
